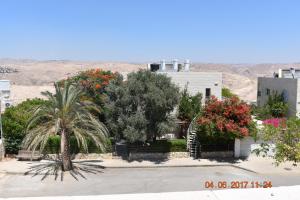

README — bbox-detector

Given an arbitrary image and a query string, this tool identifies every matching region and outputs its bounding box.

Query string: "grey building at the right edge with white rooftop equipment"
[257,68,300,117]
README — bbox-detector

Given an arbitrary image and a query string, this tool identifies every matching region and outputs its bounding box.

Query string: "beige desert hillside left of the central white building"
[0,59,146,103]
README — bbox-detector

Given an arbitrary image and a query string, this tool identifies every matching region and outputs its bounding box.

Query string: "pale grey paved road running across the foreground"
[0,166,300,197]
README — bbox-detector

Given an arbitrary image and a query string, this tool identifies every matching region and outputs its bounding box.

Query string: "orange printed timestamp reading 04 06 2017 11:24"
[204,181,272,189]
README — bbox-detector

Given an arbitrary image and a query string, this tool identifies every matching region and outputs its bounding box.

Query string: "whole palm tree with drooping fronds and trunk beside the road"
[23,82,108,171]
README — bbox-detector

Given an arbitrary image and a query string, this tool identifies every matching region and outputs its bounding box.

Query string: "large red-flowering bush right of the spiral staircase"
[197,97,255,139]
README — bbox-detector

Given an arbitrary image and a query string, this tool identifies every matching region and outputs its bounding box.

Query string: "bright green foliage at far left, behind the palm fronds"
[2,99,47,154]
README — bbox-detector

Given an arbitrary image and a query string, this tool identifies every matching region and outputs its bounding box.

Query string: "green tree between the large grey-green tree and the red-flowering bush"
[177,86,202,123]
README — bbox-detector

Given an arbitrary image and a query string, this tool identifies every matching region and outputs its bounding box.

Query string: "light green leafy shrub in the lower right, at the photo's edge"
[255,118,300,165]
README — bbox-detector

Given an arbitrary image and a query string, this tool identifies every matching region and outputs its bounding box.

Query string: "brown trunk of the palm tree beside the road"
[60,130,73,171]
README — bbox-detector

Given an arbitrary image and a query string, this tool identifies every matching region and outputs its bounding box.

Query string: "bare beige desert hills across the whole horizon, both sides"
[0,59,300,103]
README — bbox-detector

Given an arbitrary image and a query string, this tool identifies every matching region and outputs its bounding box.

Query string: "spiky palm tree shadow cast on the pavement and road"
[24,159,105,181]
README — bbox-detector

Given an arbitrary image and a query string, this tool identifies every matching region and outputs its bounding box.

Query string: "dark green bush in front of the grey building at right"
[253,91,288,120]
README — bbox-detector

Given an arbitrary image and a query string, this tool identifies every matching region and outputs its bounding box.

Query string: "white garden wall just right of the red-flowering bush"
[234,137,275,158]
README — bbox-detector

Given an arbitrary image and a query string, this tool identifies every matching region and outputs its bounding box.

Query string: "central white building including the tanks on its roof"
[148,60,222,104]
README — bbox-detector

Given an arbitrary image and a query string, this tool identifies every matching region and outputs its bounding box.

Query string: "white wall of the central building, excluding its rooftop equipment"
[158,72,222,104]
